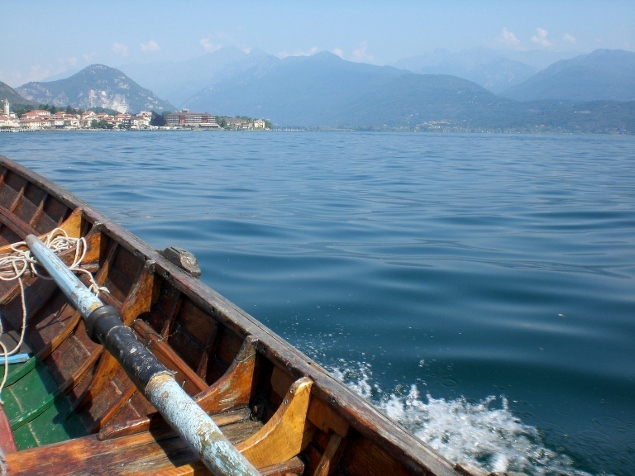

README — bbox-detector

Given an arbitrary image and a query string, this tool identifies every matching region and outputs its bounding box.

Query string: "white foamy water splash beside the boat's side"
[329,360,590,476]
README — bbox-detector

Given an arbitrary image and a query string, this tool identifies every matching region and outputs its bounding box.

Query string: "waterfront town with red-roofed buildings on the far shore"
[0,99,270,131]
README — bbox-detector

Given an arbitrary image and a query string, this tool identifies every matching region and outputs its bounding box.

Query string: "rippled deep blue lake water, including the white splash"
[0,132,635,475]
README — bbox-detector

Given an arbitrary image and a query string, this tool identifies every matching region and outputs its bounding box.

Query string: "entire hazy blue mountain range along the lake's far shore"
[7,48,635,133]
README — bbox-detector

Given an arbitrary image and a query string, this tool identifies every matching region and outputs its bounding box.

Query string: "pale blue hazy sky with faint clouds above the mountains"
[0,0,635,87]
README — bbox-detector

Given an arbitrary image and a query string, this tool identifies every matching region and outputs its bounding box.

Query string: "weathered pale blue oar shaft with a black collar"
[26,235,260,476]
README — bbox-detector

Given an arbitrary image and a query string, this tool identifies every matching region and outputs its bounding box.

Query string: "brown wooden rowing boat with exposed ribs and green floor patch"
[0,156,458,476]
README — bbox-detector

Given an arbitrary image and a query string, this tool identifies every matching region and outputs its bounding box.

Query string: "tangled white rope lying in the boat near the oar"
[0,228,108,405]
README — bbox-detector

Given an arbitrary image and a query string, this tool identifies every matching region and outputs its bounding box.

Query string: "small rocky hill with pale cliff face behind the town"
[17,64,174,112]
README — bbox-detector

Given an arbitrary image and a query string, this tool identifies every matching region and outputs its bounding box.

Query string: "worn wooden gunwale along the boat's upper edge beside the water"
[0,156,457,476]
